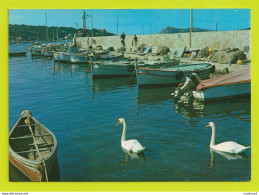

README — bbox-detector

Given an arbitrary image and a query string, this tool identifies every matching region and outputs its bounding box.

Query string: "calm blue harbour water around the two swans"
[9,45,251,181]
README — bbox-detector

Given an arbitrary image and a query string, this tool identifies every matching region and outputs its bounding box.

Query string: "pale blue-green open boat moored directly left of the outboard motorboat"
[137,63,215,86]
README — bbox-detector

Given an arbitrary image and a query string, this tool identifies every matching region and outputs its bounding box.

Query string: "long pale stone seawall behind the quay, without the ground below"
[77,30,251,59]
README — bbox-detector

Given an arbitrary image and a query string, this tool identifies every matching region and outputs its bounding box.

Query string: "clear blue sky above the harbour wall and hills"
[9,9,251,34]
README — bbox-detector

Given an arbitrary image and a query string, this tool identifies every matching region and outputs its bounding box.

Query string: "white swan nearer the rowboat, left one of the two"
[117,118,145,153]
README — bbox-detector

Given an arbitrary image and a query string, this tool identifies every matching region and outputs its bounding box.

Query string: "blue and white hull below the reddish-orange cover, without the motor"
[193,82,251,101]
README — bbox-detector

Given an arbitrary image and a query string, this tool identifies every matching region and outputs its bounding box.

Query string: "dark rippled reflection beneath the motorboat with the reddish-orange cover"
[174,98,251,121]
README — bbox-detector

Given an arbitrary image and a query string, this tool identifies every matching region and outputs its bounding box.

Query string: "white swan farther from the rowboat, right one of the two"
[206,122,250,154]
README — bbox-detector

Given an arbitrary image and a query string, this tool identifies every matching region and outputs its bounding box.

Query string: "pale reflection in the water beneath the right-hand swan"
[209,148,248,168]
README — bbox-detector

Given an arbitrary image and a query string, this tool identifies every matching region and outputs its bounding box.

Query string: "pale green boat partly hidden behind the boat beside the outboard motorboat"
[92,59,179,77]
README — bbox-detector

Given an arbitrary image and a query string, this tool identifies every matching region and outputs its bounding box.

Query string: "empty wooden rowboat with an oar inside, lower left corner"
[9,110,58,181]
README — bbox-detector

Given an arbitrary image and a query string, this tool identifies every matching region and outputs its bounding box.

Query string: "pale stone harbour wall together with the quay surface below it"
[74,30,251,72]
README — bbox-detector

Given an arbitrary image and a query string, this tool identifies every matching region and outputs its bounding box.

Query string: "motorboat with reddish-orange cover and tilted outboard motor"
[172,66,251,101]
